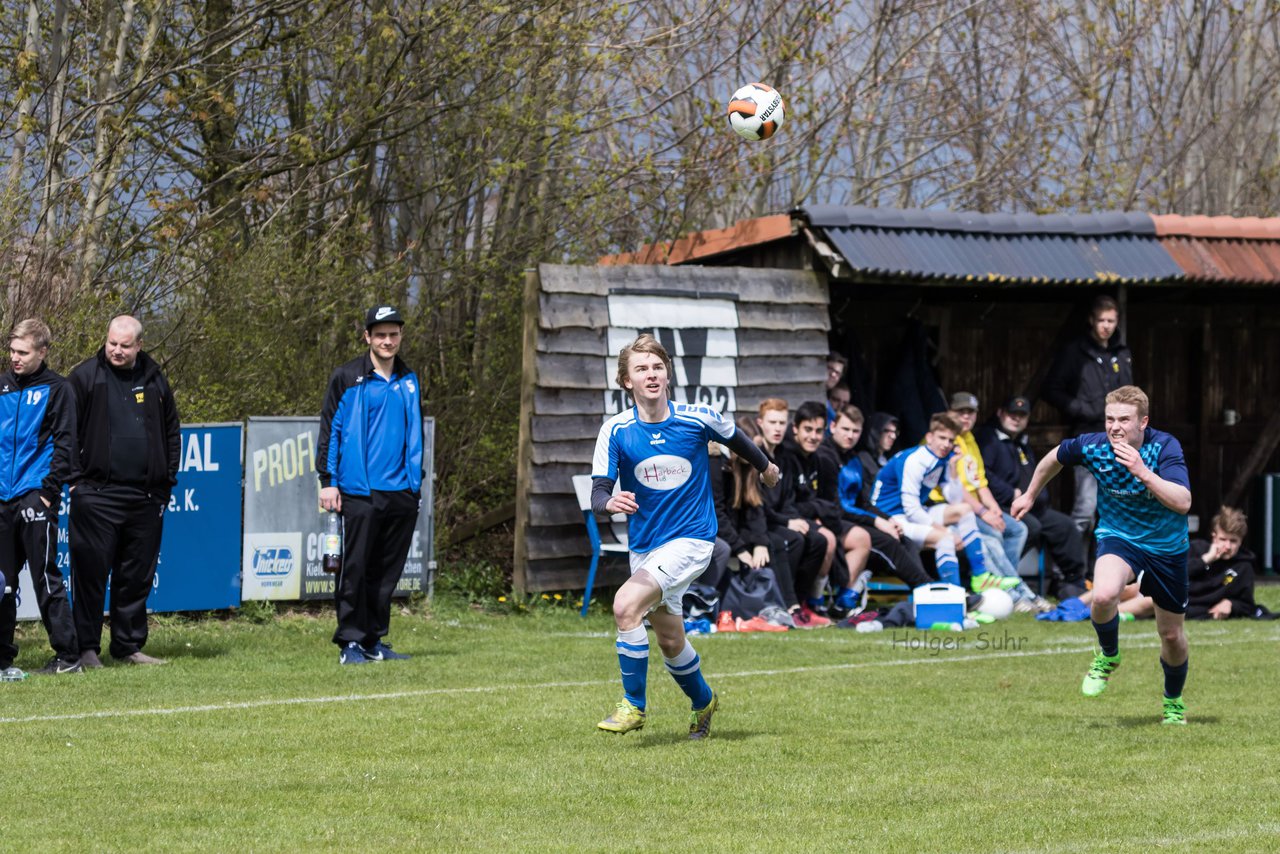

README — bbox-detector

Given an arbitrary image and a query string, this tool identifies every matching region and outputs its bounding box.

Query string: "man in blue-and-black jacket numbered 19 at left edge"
[0,319,81,681]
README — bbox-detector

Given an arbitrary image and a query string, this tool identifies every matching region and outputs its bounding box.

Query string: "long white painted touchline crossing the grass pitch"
[0,627,1275,725]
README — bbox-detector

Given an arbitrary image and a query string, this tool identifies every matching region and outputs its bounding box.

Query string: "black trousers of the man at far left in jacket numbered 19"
[0,492,79,668]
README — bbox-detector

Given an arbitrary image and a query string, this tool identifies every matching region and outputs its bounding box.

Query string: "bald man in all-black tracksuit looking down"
[67,315,182,667]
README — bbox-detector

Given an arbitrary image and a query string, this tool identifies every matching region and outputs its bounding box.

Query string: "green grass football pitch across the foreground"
[0,586,1280,851]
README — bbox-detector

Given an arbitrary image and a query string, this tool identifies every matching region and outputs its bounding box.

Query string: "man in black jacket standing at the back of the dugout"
[1043,296,1133,533]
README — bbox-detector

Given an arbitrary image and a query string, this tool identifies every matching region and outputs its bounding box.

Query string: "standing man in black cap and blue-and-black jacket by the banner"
[316,305,422,665]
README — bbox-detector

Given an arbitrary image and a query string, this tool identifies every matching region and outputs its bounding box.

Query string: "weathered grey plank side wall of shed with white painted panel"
[515,265,829,592]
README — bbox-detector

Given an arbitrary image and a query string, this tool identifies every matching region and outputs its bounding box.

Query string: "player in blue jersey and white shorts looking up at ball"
[591,334,778,739]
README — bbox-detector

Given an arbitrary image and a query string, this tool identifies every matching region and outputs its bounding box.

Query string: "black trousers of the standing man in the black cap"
[333,490,421,647]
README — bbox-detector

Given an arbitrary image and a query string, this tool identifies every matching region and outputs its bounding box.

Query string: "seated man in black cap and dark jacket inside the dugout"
[974,396,1084,599]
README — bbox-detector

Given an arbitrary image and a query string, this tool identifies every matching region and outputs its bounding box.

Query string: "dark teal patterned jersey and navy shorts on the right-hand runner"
[1057,428,1190,613]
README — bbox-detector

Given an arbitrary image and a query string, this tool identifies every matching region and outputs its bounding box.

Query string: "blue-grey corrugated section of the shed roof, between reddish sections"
[796,205,1183,284]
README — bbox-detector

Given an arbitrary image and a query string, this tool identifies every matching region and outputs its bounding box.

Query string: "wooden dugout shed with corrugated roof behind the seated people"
[516,206,1280,590]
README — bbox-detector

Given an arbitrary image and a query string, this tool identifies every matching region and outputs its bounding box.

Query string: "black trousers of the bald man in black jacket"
[68,483,165,658]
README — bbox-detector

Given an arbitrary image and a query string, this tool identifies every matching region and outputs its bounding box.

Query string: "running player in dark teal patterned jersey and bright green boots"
[1011,385,1192,723]
